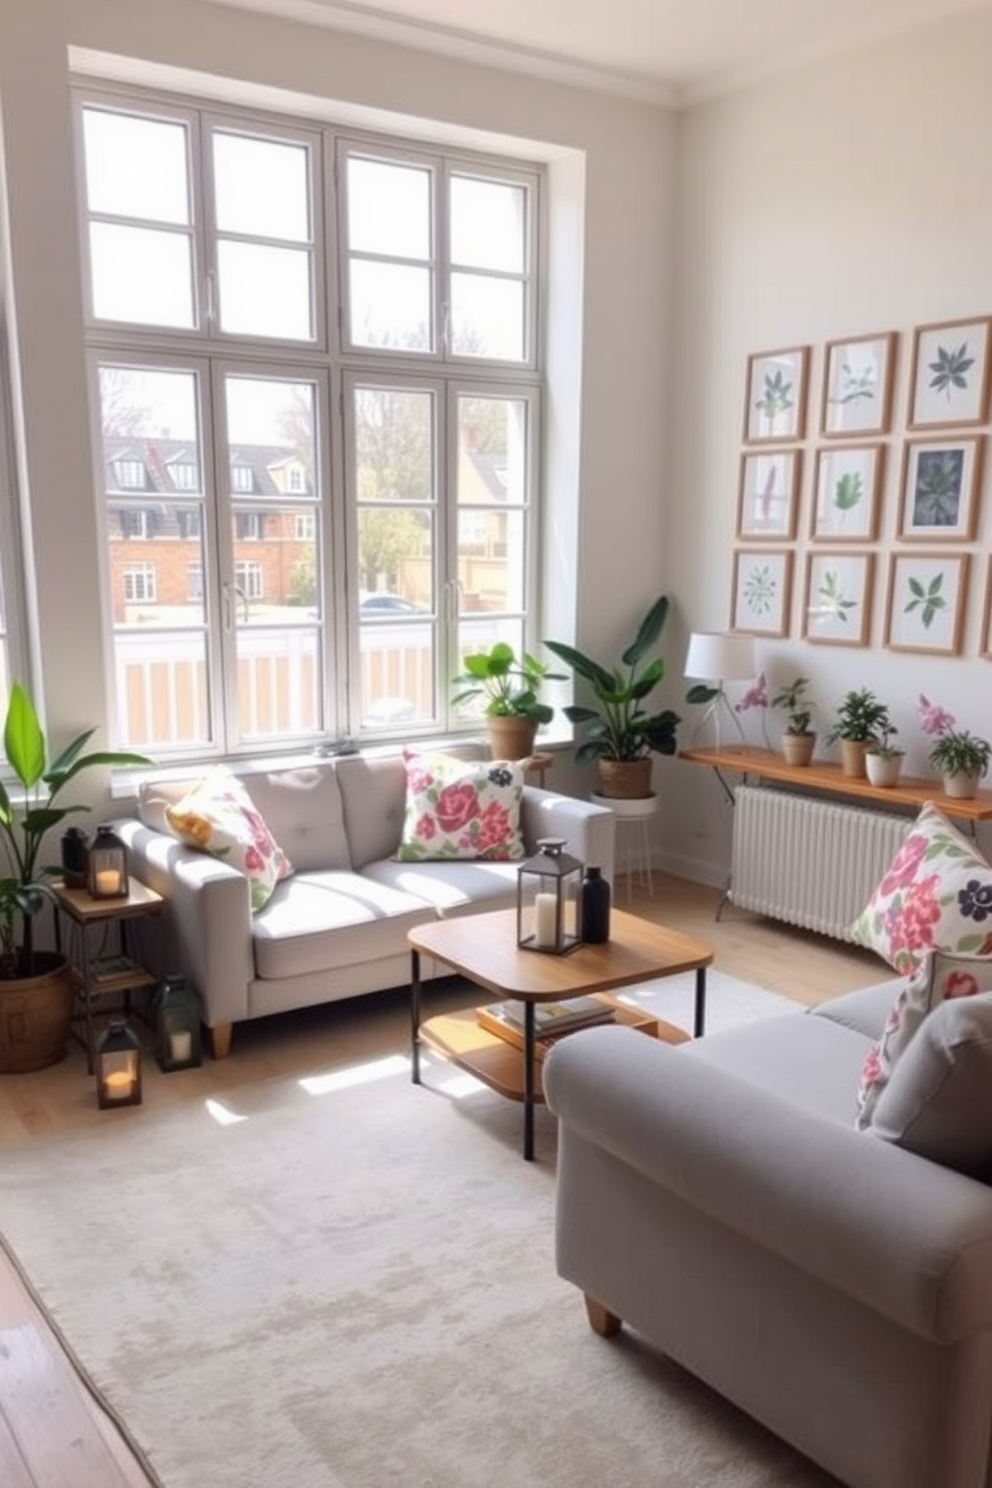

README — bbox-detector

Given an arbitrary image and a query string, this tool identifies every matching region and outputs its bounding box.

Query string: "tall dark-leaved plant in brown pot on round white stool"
[544,594,681,801]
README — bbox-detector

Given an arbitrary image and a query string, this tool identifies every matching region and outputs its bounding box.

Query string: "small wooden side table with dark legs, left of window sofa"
[52,878,165,1074]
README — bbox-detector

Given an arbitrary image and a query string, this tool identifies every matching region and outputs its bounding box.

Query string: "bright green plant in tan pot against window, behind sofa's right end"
[451,641,565,759]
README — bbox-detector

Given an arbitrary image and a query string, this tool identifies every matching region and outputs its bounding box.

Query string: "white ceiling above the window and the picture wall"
[199,0,989,106]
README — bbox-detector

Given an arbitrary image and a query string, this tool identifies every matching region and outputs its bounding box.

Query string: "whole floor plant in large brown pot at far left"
[0,682,152,1074]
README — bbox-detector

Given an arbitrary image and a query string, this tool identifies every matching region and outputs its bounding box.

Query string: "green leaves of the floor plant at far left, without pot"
[0,682,153,981]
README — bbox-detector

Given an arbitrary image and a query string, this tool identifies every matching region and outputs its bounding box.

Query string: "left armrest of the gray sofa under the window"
[113,818,254,1028]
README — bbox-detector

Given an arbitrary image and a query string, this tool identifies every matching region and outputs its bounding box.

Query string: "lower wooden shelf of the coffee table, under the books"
[419,992,689,1101]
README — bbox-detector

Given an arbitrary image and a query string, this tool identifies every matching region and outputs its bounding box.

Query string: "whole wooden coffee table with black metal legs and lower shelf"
[408,909,714,1162]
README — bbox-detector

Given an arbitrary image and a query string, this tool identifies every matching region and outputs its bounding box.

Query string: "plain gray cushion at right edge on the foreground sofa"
[867,992,992,1181]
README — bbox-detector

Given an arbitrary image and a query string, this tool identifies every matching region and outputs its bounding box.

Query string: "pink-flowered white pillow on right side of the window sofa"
[396,750,524,863]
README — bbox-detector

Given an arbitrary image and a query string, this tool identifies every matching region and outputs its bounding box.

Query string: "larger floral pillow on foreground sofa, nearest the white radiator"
[848,802,992,975]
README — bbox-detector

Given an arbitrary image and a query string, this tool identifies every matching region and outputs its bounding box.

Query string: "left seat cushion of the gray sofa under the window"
[253,872,436,979]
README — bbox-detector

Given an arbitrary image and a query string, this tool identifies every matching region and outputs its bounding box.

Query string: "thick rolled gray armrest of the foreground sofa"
[544,1027,992,1342]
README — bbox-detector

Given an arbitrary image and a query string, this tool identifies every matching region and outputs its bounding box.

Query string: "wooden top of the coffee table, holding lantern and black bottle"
[408,909,714,1001]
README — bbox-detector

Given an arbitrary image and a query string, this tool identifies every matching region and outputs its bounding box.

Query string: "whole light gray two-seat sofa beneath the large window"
[115,756,614,1058]
